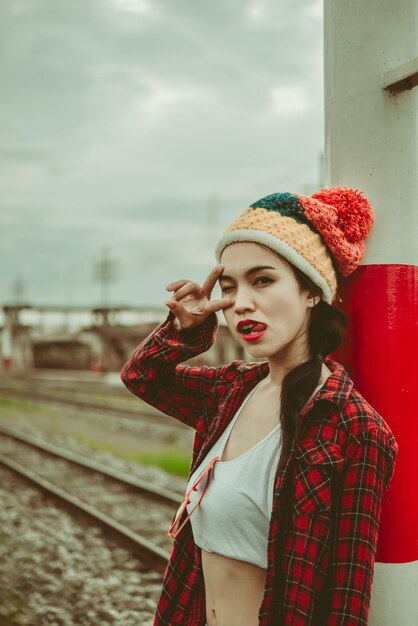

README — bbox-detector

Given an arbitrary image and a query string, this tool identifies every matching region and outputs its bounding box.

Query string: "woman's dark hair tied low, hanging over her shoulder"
[279,264,348,468]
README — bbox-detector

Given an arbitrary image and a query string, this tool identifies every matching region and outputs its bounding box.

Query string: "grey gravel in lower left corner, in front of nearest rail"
[0,467,166,626]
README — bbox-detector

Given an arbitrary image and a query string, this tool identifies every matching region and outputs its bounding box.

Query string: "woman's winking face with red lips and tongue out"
[219,242,319,362]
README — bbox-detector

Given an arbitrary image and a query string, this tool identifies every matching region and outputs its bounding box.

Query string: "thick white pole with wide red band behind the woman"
[324,0,418,626]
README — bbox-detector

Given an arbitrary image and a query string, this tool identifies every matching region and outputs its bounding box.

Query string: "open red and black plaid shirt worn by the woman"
[121,313,398,626]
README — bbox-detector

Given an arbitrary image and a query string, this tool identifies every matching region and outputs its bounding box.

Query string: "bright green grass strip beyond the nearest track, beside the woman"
[76,435,191,478]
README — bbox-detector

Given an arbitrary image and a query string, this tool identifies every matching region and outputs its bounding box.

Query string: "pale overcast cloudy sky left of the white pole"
[0,0,323,306]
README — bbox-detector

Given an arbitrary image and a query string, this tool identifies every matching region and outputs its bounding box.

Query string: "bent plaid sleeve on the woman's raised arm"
[121,312,235,434]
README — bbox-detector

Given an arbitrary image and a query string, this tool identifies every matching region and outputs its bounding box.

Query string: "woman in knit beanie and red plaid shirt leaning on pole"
[122,188,398,626]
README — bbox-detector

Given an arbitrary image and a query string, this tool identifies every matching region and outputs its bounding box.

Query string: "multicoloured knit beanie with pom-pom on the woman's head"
[215,187,374,304]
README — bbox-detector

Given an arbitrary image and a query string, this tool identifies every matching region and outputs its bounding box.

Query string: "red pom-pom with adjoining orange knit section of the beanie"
[299,187,374,276]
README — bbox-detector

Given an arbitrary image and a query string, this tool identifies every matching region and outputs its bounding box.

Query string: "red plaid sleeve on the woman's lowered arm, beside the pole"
[324,429,398,626]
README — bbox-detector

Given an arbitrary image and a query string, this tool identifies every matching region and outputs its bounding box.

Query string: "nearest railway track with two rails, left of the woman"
[0,426,181,573]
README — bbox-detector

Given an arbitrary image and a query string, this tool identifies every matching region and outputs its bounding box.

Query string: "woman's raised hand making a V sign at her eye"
[165,265,233,330]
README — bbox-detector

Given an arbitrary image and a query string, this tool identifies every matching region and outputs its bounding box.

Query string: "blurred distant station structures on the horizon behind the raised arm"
[0,306,250,371]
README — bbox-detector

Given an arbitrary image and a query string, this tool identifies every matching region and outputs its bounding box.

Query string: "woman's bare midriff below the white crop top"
[202,550,266,626]
